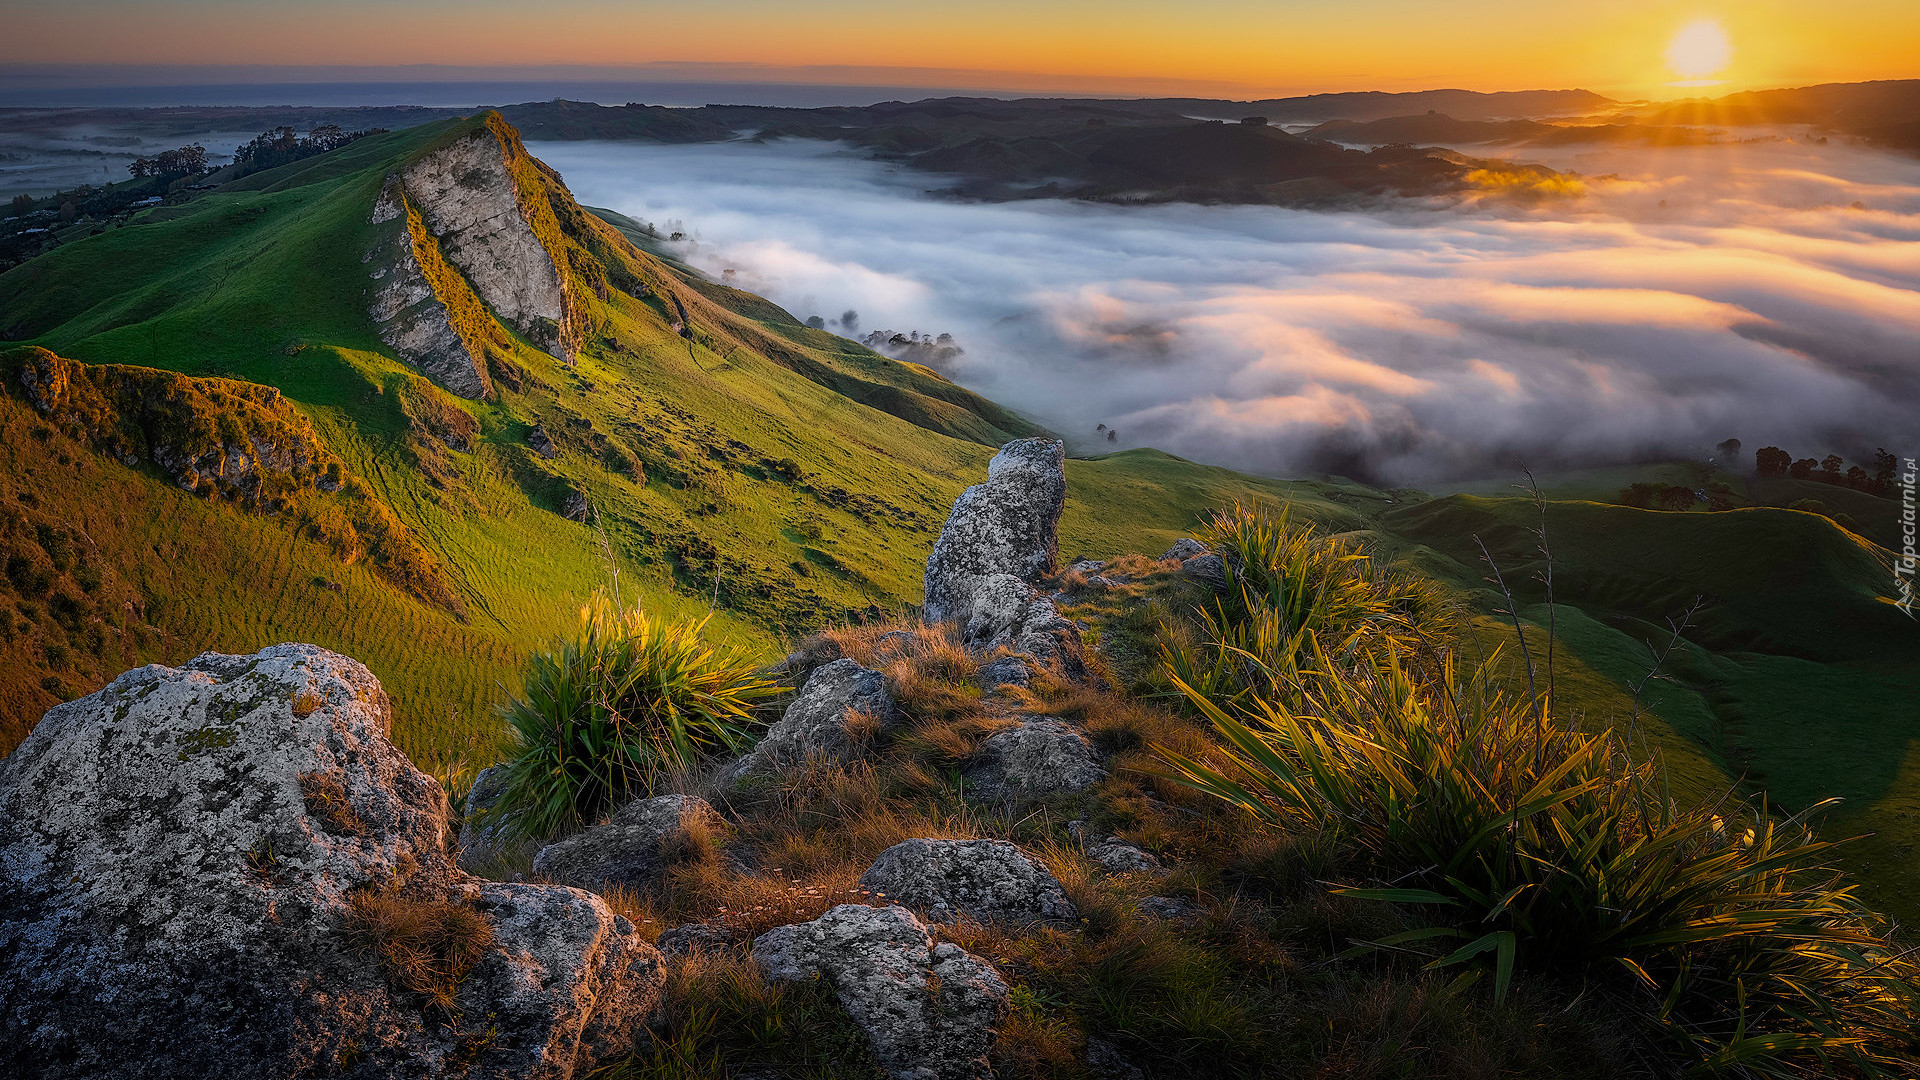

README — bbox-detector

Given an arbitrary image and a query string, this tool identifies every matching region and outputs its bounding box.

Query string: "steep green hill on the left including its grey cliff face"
[0,115,1338,761]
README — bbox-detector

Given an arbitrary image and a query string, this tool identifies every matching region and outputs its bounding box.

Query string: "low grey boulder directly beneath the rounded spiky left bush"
[534,796,726,892]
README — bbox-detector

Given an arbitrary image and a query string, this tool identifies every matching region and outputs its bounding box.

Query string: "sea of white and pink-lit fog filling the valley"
[530,138,1920,484]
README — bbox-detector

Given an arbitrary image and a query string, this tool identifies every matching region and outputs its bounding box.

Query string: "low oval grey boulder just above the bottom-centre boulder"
[860,840,1079,924]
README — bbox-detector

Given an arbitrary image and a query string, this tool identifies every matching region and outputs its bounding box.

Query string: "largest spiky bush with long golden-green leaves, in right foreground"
[1162,634,1920,1076]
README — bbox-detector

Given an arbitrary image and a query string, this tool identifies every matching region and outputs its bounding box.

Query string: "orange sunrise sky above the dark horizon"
[0,0,1920,98]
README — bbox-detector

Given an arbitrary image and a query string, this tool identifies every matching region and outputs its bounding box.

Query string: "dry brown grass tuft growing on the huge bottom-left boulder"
[351,890,493,1013]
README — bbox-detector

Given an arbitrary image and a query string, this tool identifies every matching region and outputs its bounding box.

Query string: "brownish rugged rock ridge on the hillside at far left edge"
[0,348,346,505]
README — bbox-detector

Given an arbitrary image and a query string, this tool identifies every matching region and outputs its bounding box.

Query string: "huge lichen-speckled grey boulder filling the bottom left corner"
[0,646,662,1080]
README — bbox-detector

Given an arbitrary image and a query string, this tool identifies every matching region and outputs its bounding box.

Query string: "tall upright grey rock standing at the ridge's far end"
[924,438,1085,676]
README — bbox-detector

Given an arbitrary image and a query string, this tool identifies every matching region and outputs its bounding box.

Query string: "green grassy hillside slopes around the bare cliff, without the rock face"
[0,113,1336,763]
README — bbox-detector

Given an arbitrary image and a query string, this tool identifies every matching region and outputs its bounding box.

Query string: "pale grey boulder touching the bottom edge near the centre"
[753,903,1008,1080]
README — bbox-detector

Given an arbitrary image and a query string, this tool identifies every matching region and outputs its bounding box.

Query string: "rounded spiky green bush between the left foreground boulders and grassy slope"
[493,598,780,838]
